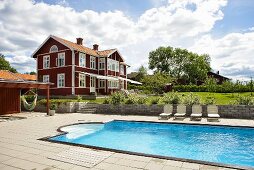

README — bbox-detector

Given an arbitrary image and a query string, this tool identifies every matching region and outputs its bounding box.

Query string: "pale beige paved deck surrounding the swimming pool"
[0,112,254,170]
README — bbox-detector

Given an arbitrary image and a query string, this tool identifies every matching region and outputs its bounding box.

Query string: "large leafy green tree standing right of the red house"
[149,46,211,84]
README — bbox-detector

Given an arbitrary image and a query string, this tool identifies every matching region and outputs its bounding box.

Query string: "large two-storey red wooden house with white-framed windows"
[32,35,139,96]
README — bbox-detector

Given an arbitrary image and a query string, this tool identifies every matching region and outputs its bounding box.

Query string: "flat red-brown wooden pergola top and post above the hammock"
[0,80,53,114]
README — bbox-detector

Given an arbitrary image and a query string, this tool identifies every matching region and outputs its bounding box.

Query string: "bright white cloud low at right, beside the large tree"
[191,32,254,78]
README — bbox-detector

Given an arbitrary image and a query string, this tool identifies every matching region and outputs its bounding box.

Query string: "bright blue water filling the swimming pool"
[50,121,254,168]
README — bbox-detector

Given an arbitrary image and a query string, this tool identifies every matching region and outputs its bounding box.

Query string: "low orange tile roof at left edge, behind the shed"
[0,70,36,81]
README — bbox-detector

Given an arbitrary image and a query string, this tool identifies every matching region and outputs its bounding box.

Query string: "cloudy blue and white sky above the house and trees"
[0,0,254,80]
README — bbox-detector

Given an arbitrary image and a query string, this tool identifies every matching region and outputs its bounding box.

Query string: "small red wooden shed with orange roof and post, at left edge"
[0,70,51,115]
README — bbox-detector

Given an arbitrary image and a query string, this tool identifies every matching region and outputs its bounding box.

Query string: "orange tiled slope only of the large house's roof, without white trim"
[52,36,116,57]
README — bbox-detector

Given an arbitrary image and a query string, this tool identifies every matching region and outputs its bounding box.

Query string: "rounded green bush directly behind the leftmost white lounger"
[159,92,181,104]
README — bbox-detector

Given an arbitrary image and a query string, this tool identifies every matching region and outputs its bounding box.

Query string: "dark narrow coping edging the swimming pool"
[37,119,254,170]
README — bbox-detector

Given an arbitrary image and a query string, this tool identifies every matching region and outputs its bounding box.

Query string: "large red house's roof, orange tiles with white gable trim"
[32,35,124,61]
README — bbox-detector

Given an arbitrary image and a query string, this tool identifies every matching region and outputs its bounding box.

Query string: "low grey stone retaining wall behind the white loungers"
[31,102,254,119]
